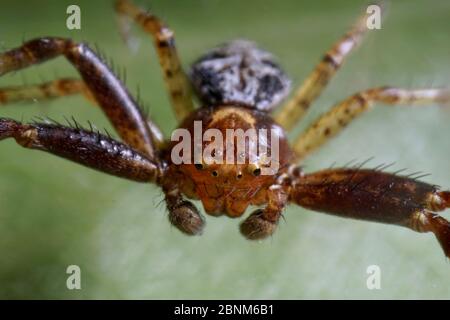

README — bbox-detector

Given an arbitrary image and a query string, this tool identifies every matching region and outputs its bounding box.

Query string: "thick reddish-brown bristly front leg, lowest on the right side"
[290,168,450,258]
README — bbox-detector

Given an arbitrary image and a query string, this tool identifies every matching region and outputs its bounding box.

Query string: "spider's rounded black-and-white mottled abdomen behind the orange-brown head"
[190,40,290,111]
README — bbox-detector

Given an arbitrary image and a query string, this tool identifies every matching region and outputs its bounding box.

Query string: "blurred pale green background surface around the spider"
[0,0,450,299]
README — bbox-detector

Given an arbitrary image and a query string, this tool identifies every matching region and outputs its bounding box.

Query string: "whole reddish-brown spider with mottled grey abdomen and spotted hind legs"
[0,0,450,257]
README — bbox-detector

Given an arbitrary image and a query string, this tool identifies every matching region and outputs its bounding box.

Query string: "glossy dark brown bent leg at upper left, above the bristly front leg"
[0,38,155,159]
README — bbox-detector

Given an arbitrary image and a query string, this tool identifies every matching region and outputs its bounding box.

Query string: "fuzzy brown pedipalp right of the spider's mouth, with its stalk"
[240,185,288,240]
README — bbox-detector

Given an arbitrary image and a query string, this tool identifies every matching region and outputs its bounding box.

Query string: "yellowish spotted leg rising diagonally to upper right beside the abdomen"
[275,5,380,130]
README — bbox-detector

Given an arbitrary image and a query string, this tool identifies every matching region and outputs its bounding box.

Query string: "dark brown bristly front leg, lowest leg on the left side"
[0,118,162,182]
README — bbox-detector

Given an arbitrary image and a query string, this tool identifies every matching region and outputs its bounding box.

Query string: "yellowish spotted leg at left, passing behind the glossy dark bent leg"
[0,78,164,148]
